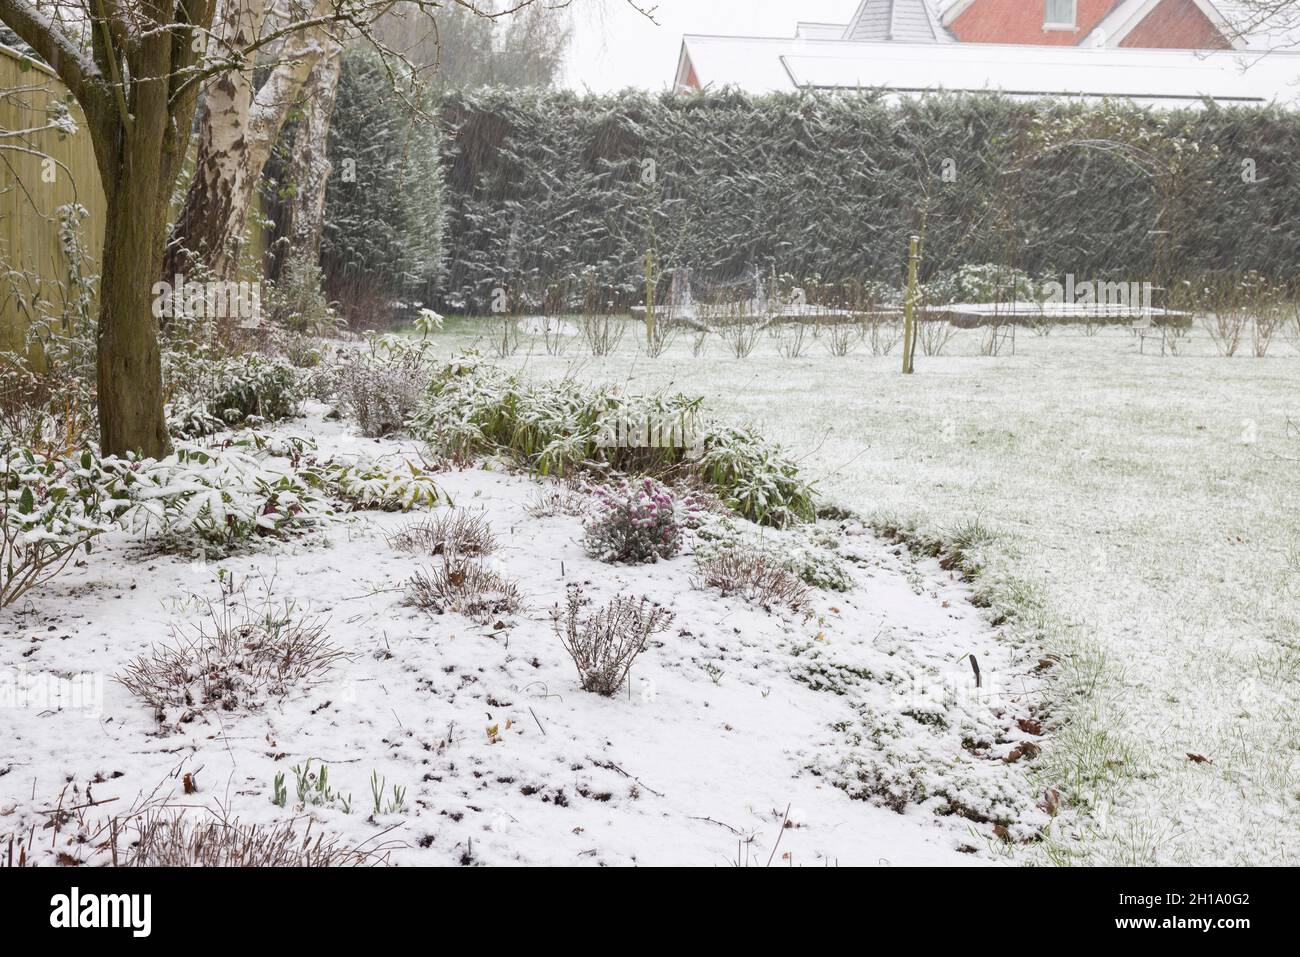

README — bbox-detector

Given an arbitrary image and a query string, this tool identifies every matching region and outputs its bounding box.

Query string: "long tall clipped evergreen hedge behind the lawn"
[442,90,1300,311]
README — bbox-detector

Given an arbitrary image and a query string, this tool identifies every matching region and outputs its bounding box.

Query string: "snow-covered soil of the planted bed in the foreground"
[0,406,1047,866]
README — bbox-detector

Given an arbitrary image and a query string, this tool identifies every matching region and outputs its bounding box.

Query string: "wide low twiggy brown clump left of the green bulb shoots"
[114,597,347,722]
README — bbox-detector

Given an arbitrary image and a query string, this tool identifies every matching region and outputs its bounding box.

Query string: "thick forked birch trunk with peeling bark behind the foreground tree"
[161,0,330,280]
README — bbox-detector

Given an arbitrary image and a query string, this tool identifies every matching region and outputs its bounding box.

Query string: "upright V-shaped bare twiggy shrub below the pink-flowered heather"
[551,585,673,697]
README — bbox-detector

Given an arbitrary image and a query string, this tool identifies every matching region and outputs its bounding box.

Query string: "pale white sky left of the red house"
[566,0,858,92]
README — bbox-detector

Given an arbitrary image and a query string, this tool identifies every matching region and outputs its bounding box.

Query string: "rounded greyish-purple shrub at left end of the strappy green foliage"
[334,337,433,437]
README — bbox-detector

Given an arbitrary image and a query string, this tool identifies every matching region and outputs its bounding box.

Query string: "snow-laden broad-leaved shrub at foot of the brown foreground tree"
[114,445,333,550]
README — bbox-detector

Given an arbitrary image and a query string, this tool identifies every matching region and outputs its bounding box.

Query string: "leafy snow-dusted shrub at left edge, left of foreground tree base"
[0,445,127,607]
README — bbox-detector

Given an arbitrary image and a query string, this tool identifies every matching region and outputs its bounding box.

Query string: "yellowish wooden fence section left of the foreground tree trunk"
[0,47,105,350]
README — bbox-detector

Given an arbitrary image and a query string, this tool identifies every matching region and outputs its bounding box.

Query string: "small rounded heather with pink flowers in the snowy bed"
[584,479,694,564]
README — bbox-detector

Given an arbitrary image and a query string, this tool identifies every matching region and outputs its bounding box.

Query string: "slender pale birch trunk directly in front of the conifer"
[285,29,343,261]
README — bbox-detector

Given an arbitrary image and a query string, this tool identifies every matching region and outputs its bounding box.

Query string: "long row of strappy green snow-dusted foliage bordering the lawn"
[412,355,814,527]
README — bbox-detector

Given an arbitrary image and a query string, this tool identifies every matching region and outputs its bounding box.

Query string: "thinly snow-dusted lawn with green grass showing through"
[439,317,1300,865]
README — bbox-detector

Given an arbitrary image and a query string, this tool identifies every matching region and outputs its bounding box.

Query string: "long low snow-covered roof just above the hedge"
[679,35,1300,105]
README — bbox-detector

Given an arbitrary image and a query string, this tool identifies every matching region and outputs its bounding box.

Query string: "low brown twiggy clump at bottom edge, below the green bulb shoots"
[112,809,389,867]
